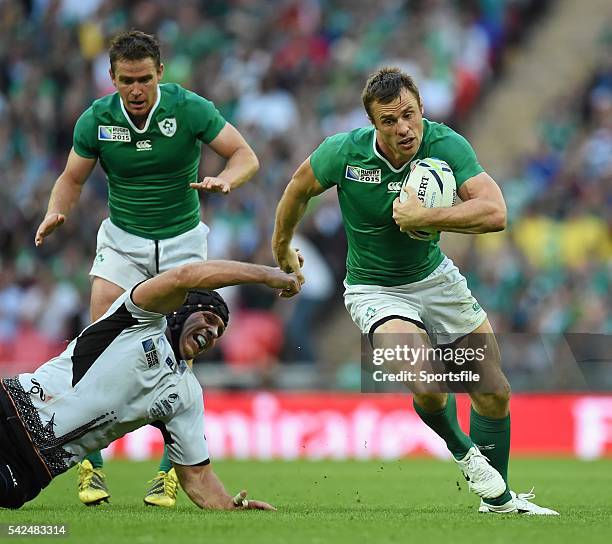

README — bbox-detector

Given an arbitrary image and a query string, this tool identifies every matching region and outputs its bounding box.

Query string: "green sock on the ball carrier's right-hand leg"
[470,407,511,505]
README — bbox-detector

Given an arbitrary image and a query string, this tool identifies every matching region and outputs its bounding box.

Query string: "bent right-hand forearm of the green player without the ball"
[189,123,259,194]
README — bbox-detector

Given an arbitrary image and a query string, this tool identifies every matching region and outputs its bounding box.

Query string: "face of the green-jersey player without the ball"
[110,57,164,117]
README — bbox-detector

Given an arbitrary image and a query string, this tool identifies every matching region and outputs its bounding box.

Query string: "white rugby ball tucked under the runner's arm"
[399,158,457,240]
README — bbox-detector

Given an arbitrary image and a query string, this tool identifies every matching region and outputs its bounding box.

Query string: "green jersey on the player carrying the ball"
[310,119,484,286]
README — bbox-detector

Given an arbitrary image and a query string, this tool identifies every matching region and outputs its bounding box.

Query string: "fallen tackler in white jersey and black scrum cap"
[0,261,300,510]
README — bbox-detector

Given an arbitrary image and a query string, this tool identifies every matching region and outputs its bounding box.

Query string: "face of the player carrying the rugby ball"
[370,89,423,167]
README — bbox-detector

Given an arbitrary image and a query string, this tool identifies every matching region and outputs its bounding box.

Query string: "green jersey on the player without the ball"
[73,83,225,240]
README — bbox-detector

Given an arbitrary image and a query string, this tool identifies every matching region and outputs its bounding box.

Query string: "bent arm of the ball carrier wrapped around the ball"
[393,172,506,234]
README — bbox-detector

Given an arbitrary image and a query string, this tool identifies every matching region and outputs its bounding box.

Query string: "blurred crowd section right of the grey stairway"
[456,25,612,389]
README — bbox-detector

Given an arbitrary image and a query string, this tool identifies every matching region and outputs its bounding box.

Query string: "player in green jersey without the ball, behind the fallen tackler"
[35,31,259,506]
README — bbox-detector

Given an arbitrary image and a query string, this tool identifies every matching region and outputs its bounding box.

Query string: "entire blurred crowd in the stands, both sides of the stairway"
[0,0,612,382]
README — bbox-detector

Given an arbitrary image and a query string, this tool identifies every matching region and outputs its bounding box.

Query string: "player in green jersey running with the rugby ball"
[272,68,557,515]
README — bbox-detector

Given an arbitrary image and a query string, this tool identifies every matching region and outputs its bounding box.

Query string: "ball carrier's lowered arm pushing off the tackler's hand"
[272,157,325,283]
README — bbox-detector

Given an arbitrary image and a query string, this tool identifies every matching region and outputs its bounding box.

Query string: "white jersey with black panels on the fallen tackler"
[2,292,208,476]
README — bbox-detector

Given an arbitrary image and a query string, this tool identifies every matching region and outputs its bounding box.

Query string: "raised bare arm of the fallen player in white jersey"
[132,261,301,314]
